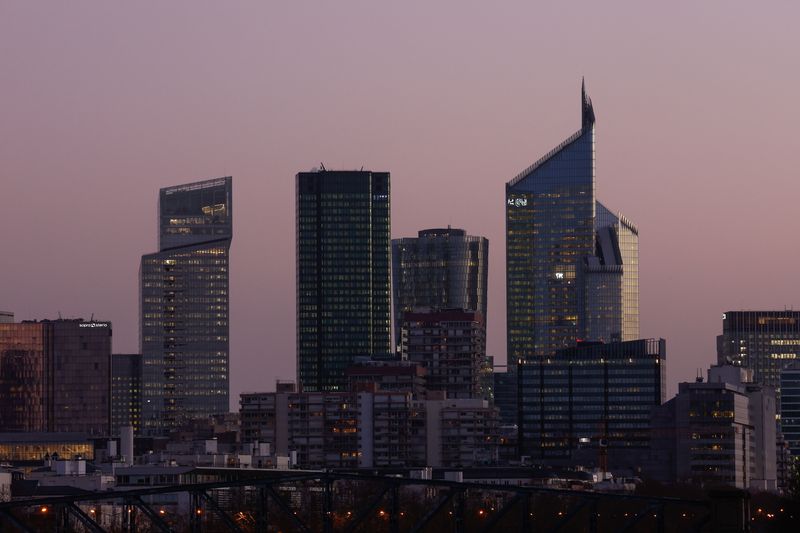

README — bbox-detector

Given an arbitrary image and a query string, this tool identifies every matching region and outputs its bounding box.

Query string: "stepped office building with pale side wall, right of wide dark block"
[647,365,777,491]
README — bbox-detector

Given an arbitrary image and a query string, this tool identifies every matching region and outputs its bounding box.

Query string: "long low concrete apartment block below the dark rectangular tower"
[240,382,498,469]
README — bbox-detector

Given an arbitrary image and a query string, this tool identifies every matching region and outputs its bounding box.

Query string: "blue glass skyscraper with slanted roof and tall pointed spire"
[506,81,639,455]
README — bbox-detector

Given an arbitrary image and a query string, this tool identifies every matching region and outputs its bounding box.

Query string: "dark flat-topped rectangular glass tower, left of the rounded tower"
[296,168,391,392]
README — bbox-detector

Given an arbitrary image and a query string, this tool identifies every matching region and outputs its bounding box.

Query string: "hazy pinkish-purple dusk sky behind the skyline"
[0,0,800,409]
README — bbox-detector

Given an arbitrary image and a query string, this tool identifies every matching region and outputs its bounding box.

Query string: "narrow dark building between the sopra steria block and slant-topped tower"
[111,353,142,435]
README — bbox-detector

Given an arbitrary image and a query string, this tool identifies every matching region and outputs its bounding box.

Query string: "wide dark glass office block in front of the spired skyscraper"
[528,339,666,469]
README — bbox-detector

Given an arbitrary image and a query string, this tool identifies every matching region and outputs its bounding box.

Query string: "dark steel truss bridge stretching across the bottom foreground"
[0,471,749,533]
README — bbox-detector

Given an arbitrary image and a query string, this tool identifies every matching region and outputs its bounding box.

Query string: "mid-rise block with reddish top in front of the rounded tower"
[401,309,486,399]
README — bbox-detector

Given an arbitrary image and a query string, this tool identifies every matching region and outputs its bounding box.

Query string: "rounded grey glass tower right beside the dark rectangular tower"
[392,227,489,346]
